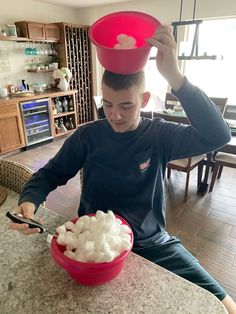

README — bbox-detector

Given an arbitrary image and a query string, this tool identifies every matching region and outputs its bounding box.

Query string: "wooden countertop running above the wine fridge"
[0,89,78,105]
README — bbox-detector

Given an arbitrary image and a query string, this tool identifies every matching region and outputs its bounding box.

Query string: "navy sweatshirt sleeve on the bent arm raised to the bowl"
[160,78,231,161]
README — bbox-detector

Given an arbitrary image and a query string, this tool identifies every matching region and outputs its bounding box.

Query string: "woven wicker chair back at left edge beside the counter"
[0,159,45,207]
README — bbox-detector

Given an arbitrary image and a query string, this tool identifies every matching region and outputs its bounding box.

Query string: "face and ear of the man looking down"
[102,84,149,133]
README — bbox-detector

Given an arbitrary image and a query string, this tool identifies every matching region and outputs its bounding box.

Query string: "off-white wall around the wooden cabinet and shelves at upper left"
[0,0,78,87]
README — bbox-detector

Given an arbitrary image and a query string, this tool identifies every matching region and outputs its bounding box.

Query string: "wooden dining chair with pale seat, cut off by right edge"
[209,152,236,192]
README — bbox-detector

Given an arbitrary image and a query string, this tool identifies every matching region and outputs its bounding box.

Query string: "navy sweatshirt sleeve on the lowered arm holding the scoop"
[18,129,83,210]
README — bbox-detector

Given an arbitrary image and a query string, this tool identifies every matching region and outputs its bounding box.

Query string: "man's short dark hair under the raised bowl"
[102,70,145,90]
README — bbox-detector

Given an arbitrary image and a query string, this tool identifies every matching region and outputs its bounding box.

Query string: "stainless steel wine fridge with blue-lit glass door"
[20,98,52,146]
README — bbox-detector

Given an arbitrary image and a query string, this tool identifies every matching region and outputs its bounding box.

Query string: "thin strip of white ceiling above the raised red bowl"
[36,0,135,8]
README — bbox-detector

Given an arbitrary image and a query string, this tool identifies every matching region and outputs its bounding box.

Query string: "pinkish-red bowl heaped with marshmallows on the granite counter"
[50,211,133,286]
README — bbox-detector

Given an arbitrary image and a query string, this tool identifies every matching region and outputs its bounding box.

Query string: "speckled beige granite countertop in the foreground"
[0,191,227,314]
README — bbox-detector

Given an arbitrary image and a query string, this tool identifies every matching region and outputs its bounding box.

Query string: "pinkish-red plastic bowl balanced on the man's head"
[88,11,161,74]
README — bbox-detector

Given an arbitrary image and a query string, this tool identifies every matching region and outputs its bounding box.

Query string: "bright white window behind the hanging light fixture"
[183,19,236,105]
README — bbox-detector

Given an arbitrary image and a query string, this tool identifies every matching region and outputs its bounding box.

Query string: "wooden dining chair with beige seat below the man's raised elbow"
[154,113,206,202]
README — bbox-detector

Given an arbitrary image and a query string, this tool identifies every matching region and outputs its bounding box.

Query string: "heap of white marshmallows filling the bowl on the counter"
[56,210,131,263]
